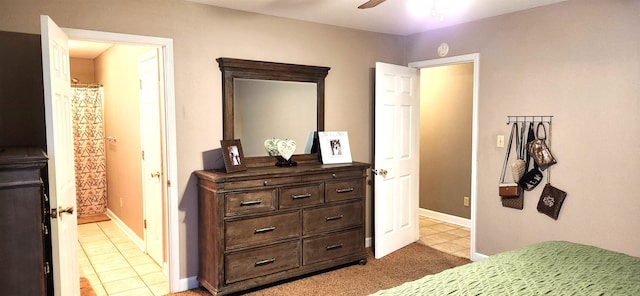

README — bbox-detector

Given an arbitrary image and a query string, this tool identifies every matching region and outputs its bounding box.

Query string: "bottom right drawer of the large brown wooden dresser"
[302,228,364,265]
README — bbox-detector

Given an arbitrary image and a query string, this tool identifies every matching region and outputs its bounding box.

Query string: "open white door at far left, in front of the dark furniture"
[40,15,80,296]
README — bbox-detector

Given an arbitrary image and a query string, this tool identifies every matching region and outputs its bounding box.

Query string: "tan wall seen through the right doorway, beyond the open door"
[420,63,473,218]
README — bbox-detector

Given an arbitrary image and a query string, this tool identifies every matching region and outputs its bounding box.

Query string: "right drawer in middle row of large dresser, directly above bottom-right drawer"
[302,201,362,235]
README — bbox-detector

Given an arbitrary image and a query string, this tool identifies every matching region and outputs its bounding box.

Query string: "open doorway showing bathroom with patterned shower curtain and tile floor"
[69,40,169,294]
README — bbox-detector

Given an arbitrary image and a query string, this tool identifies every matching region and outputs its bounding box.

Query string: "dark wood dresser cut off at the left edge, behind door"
[0,148,53,295]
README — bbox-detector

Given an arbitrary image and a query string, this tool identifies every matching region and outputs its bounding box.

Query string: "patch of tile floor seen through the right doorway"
[419,216,471,258]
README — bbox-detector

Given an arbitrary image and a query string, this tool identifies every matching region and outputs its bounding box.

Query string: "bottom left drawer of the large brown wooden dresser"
[224,241,300,284]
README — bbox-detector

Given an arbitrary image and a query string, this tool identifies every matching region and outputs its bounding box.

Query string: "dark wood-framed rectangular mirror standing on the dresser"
[217,58,330,165]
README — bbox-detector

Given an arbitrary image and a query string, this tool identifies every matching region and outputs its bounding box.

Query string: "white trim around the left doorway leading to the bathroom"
[61,28,180,292]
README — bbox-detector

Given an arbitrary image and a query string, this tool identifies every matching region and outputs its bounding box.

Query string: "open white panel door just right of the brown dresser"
[374,63,420,258]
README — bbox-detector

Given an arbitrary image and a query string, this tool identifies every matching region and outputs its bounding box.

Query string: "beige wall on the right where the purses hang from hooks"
[407,0,640,256]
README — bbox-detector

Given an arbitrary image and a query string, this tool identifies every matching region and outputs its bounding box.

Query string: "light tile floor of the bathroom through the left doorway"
[78,221,169,296]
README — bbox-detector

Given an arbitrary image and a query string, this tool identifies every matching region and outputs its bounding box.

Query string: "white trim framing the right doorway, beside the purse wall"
[409,53,486,261]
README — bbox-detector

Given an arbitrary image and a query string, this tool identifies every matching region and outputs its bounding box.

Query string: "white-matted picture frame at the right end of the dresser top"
[318,131,353,164]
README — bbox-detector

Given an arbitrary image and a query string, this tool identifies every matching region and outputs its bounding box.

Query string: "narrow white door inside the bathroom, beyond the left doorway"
[138,49,164,266]
